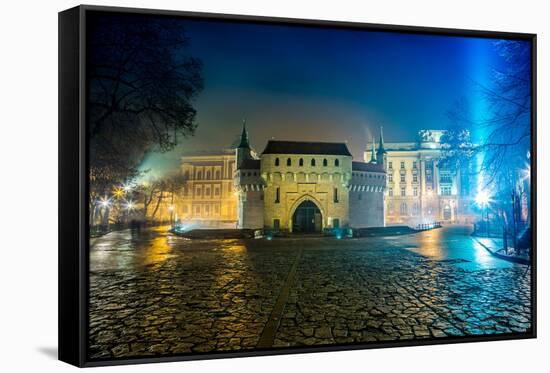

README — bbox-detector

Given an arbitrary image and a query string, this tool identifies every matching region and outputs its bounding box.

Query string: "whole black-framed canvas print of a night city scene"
[59,6,536,366]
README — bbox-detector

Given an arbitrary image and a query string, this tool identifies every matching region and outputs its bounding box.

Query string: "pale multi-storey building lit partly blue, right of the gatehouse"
[365,130,474,226]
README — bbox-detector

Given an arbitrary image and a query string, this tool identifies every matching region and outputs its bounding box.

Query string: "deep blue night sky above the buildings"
[142,16,512,176]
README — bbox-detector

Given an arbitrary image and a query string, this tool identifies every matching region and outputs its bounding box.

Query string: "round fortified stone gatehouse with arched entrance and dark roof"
[234,127,386,232]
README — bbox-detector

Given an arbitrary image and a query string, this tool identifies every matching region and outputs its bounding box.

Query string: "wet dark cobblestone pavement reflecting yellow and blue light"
[90,224,531,358]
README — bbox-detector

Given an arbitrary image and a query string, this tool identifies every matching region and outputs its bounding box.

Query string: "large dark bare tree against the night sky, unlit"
[88,14,203,198]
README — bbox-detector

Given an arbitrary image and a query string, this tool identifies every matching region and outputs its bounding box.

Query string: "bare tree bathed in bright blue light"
[444,40,531,250]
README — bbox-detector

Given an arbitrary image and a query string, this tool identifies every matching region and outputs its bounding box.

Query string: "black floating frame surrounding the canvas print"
[58,5,537,367]
